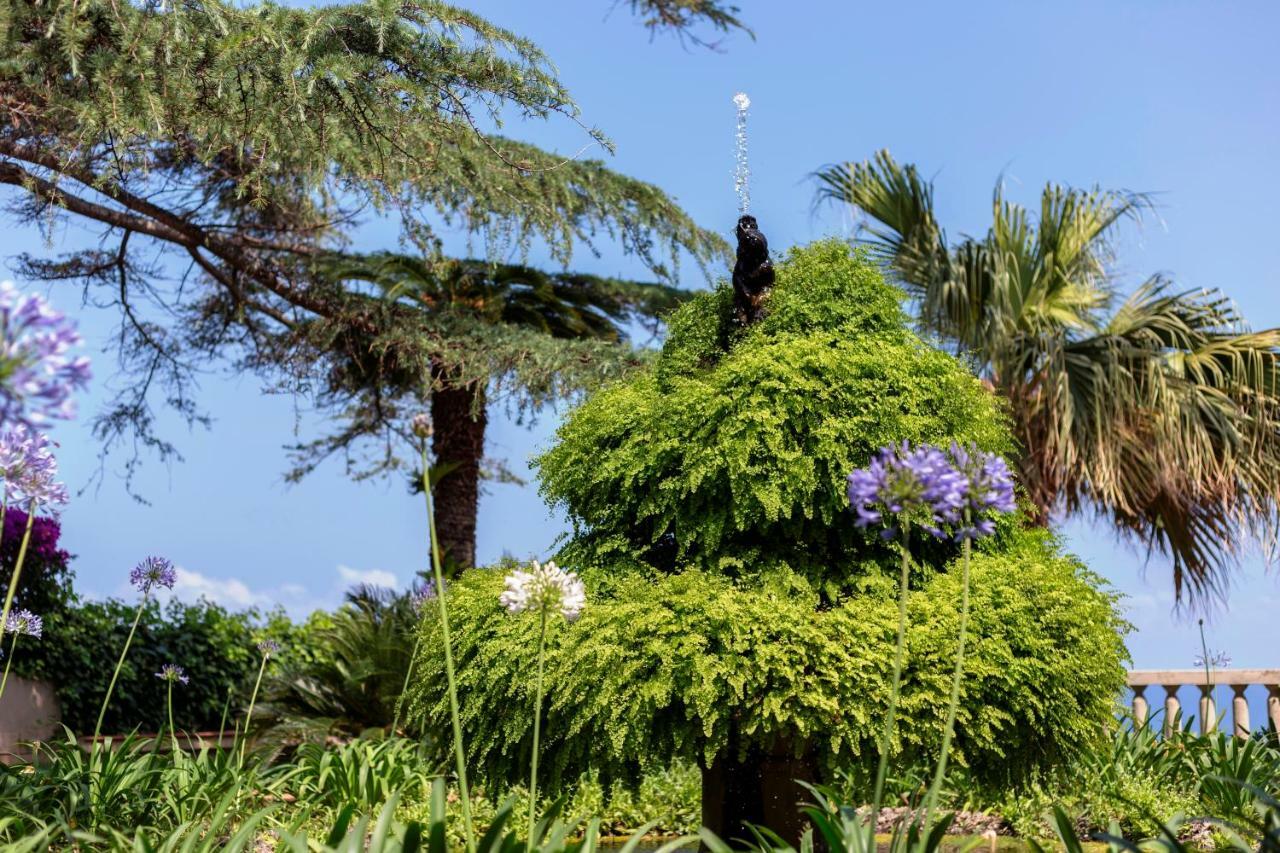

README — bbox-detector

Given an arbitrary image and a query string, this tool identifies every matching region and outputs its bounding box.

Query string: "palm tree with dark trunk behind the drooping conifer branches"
[316,252,684,569]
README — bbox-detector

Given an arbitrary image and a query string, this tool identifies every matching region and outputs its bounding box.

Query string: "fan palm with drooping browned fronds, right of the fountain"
[817,151,1280,602]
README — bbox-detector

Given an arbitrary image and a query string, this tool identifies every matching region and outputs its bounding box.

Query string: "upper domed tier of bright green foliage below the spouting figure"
[538,242,1009,584]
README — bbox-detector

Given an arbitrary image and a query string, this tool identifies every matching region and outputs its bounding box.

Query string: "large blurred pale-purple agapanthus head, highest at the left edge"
[0,282,90,428]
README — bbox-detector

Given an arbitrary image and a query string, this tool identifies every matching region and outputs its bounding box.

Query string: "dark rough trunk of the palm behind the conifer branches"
[431,384,488,569]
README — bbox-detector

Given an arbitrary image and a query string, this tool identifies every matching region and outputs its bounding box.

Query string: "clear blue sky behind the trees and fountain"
[0,0,1280,696]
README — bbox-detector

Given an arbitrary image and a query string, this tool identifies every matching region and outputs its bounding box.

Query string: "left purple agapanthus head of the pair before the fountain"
[849,442,968,538]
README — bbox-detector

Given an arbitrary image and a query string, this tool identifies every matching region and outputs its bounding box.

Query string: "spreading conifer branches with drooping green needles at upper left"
[0,0,727,479]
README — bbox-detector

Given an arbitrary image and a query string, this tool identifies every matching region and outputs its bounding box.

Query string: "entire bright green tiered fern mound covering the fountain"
[413,236,1125,784]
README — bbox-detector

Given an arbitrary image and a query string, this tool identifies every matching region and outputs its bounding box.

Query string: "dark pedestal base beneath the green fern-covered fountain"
[703,726,819,848]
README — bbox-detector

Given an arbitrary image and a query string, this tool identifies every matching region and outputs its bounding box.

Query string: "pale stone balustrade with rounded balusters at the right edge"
[1129,670,1280,738]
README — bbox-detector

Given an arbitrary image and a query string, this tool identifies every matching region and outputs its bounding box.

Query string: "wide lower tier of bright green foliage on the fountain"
[404,532,1124,780]
